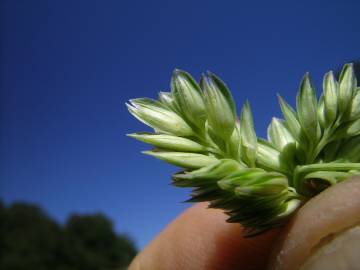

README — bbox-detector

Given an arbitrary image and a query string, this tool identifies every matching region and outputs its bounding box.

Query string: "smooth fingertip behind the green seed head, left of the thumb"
[129,203,280,270]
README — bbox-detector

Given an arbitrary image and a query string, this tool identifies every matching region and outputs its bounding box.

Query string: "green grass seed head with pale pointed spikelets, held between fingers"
[128,64,360,235]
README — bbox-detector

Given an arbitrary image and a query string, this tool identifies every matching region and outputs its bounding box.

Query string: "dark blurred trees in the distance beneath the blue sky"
[0,202,136,270]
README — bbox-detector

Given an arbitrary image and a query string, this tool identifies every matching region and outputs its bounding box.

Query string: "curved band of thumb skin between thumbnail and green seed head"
[271,176,360,270]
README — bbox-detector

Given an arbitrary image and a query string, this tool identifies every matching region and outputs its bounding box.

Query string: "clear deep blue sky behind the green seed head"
[0,0,360,248]
